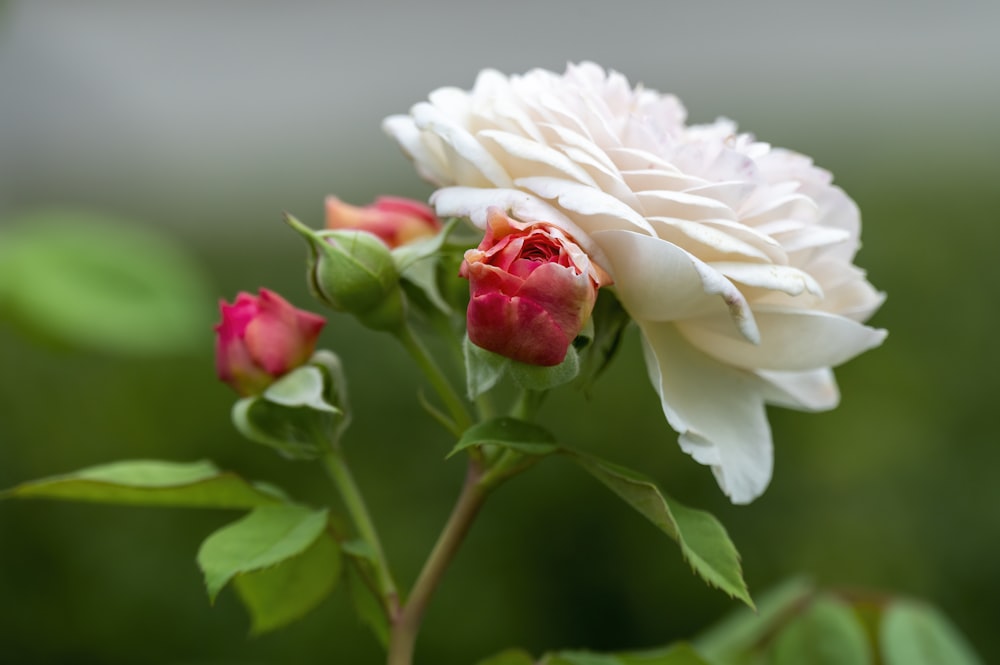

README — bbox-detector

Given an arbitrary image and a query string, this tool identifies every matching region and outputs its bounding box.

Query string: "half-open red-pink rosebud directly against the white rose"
[459,208,611,366]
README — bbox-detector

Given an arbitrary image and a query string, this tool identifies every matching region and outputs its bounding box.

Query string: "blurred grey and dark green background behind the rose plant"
[0,0,1000,664]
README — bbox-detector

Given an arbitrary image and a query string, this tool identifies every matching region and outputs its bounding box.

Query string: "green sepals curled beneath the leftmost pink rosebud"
[232,360,349,460]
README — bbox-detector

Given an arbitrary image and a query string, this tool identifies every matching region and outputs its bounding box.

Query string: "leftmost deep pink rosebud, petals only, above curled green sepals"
[215,289,326,395]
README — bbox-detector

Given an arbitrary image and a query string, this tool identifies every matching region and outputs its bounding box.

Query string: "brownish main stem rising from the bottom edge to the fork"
[387,459,492,665]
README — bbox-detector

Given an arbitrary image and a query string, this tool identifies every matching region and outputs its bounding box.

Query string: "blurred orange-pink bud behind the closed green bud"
[326,196,441,249]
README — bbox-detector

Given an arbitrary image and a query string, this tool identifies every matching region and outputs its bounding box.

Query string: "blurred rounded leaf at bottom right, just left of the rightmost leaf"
[770,596,872,665]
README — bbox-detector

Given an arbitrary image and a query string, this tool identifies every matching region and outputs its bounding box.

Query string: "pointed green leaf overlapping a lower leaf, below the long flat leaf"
[198,505,327,602]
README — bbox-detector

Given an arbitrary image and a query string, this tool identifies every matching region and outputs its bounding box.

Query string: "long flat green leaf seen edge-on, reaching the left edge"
[0,460,287,508]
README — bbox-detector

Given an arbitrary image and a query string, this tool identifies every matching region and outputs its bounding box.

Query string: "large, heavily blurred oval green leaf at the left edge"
[0,210,215,355]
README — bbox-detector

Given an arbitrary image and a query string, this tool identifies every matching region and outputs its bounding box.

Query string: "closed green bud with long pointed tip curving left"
[286,216,403,331]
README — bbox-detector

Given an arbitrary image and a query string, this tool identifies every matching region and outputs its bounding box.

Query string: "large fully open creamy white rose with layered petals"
[384,63,886,503]
